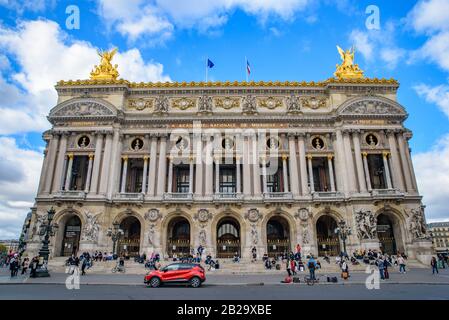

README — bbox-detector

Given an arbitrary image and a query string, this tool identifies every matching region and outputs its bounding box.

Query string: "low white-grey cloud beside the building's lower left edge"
[0,137,43,239]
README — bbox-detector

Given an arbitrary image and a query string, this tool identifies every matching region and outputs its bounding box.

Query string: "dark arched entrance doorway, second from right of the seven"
[316,215,341,256]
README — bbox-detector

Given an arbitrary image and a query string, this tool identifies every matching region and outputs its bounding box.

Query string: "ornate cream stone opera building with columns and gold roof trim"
[27,47,431,261]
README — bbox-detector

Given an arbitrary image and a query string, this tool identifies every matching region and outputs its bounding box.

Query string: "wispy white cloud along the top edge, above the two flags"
[98,0,312,43]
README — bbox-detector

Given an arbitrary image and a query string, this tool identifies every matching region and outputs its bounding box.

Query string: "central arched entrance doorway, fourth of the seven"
[217,217,241,258]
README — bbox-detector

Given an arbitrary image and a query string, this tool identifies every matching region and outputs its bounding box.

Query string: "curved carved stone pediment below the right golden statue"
[337,96,407,116]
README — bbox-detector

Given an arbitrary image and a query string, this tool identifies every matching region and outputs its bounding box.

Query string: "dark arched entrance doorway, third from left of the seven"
[167,217,190,258]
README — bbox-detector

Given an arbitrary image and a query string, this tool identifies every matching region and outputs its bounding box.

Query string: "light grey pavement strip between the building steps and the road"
[0,268,449,290]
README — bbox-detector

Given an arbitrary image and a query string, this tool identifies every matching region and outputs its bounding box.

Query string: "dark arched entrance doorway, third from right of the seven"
[267,216,291,257]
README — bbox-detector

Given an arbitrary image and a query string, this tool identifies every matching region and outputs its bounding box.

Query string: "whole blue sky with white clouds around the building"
[0,0,449,238]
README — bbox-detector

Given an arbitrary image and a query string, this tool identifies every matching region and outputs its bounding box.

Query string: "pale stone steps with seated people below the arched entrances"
[48,257,427,275]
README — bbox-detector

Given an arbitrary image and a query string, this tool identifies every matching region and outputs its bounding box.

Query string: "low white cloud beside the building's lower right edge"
[413,135,449,221]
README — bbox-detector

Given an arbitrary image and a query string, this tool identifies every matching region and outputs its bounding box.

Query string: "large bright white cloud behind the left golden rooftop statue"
[0,20,170,134]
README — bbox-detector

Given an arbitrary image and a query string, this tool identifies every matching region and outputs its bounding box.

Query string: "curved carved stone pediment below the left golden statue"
[50,98,117,118]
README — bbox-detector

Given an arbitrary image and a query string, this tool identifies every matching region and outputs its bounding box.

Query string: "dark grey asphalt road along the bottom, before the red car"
[0,284,449,300]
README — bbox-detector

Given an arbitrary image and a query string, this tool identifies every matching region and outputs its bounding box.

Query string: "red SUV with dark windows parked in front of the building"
[144,263,206,288]
